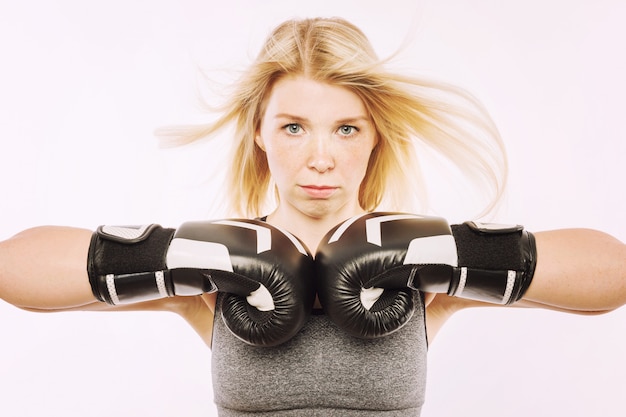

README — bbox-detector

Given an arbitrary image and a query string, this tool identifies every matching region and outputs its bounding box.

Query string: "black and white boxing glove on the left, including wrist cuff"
[87,219,315,346]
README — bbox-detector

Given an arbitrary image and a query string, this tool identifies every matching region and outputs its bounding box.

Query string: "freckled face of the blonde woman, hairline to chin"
[256,76,377,223]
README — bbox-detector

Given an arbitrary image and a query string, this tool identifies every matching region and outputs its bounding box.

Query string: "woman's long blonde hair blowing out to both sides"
[158,18,507,216]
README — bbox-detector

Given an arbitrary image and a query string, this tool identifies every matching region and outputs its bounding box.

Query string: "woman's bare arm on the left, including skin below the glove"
[0,226,215,346]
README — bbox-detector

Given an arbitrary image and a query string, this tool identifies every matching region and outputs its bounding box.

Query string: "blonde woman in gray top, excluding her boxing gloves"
[0,19,626,416]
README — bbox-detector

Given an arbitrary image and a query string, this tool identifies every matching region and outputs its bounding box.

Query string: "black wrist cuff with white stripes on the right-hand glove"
[448,222,537,304]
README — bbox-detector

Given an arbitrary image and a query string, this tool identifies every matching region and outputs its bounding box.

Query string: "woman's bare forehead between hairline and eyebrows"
[265,76,367,118]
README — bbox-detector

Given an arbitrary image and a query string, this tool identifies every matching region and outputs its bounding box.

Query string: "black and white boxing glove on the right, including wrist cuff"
[315,213,537,338]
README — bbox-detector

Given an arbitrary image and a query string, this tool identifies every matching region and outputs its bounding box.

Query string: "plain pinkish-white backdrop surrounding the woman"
[0,0,626,417]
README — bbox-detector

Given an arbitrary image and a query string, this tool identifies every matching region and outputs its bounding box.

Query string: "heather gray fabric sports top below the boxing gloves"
[211,294,427,417]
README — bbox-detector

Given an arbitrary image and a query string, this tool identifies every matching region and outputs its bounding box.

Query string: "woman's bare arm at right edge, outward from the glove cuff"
[519,229,626,313]
